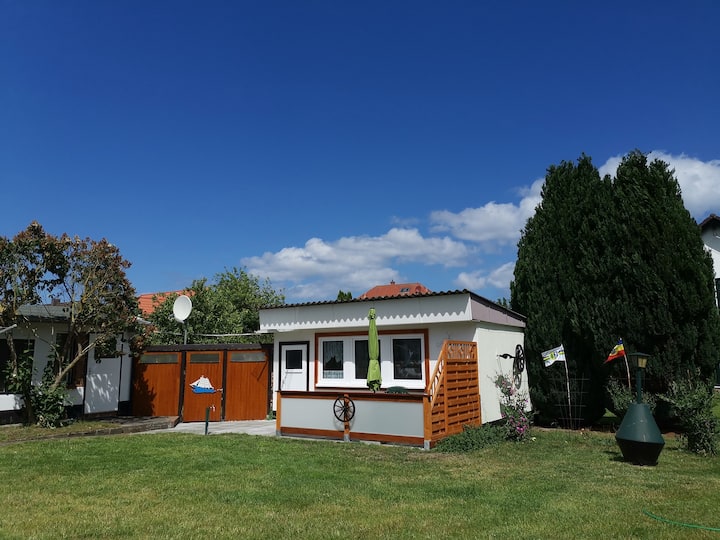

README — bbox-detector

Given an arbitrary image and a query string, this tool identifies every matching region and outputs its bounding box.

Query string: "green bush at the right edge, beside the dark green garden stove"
[660,372,720,456]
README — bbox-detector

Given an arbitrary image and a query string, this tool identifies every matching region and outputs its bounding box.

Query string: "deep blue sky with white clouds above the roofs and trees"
[0,0,720,302]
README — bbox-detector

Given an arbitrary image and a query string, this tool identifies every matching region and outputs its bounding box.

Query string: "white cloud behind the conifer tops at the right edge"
[600,150,720,220]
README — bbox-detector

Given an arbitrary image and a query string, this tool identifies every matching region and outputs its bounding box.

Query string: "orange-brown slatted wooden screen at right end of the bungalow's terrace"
[425,340,482,446]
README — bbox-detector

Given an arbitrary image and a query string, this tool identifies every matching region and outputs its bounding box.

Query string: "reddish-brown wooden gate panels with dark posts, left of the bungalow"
[132,343,272,422]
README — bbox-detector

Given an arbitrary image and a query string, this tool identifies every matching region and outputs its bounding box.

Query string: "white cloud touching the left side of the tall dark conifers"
[430,179,544,248]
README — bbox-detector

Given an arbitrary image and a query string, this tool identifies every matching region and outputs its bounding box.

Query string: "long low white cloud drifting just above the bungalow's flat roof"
[241,228,472,299]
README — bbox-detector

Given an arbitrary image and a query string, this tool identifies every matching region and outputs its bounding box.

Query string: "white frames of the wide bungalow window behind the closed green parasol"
[317,332,427,390]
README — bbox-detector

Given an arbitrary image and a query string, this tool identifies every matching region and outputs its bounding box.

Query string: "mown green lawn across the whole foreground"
[0,430,720,539]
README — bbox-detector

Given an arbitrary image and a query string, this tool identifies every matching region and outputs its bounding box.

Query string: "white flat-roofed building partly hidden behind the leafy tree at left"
[0,304,131,423]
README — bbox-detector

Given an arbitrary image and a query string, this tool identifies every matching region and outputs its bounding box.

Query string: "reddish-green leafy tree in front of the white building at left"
[0,222,142,424]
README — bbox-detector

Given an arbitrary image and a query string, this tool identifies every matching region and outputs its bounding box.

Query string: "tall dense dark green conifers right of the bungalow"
[511,152,720,422]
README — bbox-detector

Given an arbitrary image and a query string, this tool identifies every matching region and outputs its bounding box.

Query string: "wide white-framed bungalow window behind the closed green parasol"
[318,334,425,389]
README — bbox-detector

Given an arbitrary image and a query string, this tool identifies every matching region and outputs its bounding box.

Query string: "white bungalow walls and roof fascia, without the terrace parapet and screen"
[260,291,528,427]
